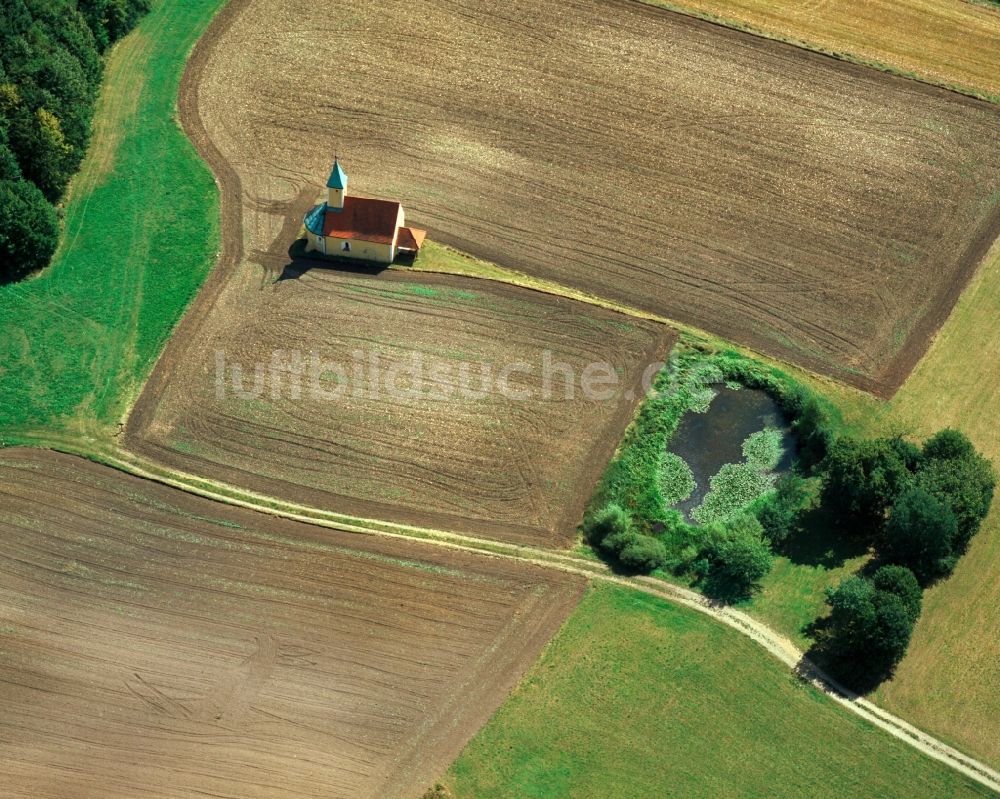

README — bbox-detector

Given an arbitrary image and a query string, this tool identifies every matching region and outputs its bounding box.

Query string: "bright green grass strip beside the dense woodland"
[0,0,222,444]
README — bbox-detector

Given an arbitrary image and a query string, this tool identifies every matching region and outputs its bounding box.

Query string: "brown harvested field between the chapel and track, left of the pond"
[130,268,672,545]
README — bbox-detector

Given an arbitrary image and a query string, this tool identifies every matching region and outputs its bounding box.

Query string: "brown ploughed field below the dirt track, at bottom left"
[0,450,582,799]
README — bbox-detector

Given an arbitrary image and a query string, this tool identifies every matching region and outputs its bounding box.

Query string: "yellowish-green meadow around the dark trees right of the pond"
[746,242,1000,768]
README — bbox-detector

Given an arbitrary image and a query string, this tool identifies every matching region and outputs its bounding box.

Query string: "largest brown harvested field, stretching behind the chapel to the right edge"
[188,0,1000,393]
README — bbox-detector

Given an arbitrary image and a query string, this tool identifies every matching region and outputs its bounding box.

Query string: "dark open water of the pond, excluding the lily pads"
[667,385,795,521]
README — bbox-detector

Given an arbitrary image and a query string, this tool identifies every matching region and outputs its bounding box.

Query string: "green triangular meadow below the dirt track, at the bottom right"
[444,586,992,799]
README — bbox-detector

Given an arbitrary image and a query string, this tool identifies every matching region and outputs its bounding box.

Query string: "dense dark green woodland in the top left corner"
[0,0,149,283]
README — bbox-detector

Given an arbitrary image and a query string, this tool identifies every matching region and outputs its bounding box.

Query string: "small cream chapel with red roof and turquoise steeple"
[303,157,427,264]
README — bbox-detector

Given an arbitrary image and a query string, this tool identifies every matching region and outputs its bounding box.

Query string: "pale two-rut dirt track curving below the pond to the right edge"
[17,440,1000,794]
